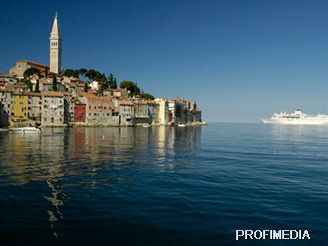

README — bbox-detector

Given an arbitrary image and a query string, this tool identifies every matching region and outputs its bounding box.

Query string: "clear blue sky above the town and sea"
[0,0,328,122]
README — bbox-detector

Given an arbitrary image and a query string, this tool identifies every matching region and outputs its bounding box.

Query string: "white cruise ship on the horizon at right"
[262,109,328,125]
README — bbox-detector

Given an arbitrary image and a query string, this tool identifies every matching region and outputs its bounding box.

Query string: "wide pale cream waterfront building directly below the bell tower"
[41,91,65,126]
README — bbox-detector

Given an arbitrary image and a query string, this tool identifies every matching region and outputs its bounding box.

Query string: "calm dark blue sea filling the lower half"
[0,124,328,246]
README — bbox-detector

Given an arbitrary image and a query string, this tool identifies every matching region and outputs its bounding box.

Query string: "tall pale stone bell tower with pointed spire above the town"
[49,12,62,74]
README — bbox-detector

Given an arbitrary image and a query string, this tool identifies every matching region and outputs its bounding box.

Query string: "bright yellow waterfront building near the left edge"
[10,93,28,125]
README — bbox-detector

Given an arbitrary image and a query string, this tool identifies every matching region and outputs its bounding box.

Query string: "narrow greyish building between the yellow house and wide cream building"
[26,92,42,125]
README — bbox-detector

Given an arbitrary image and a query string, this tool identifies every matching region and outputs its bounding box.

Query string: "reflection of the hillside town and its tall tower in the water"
[0,127,201,239]
